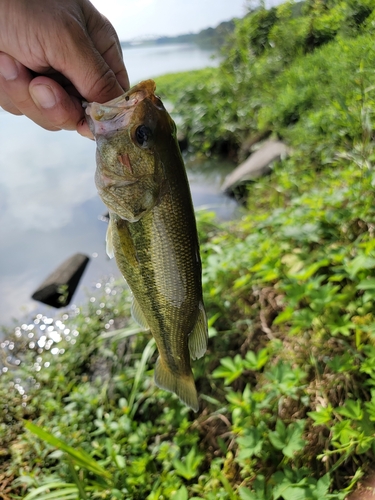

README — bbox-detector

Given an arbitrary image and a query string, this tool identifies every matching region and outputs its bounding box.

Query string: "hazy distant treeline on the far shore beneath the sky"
[121,19,235,48]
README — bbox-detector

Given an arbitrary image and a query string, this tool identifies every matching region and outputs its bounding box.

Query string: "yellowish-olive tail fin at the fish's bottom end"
[155,357,199,412]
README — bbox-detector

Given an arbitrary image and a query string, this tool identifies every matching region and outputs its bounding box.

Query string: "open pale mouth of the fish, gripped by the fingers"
[83,80,157,137]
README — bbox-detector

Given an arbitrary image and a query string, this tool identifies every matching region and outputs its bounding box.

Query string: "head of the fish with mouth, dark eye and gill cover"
[85,80,175,222]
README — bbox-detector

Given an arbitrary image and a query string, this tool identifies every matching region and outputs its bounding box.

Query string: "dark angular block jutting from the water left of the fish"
[31,253,90,308]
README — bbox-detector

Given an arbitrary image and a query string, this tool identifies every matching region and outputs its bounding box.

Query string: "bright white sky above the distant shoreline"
[91,0,251,40]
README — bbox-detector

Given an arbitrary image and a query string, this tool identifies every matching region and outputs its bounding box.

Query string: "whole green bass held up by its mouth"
[85,80,208,412]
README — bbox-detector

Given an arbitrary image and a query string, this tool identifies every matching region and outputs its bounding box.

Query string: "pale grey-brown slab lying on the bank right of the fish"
[221,140,288,194]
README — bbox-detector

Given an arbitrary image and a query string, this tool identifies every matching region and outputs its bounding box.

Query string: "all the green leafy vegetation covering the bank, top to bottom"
[0,0,375,500]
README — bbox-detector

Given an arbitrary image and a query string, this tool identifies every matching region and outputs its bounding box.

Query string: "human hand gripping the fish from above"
[0,0,129,138]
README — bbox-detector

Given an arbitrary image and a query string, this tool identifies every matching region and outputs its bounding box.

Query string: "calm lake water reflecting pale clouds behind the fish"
[0,45,235,325]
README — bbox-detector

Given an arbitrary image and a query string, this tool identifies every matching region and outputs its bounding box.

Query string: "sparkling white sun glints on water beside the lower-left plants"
[0,278,131,412]
